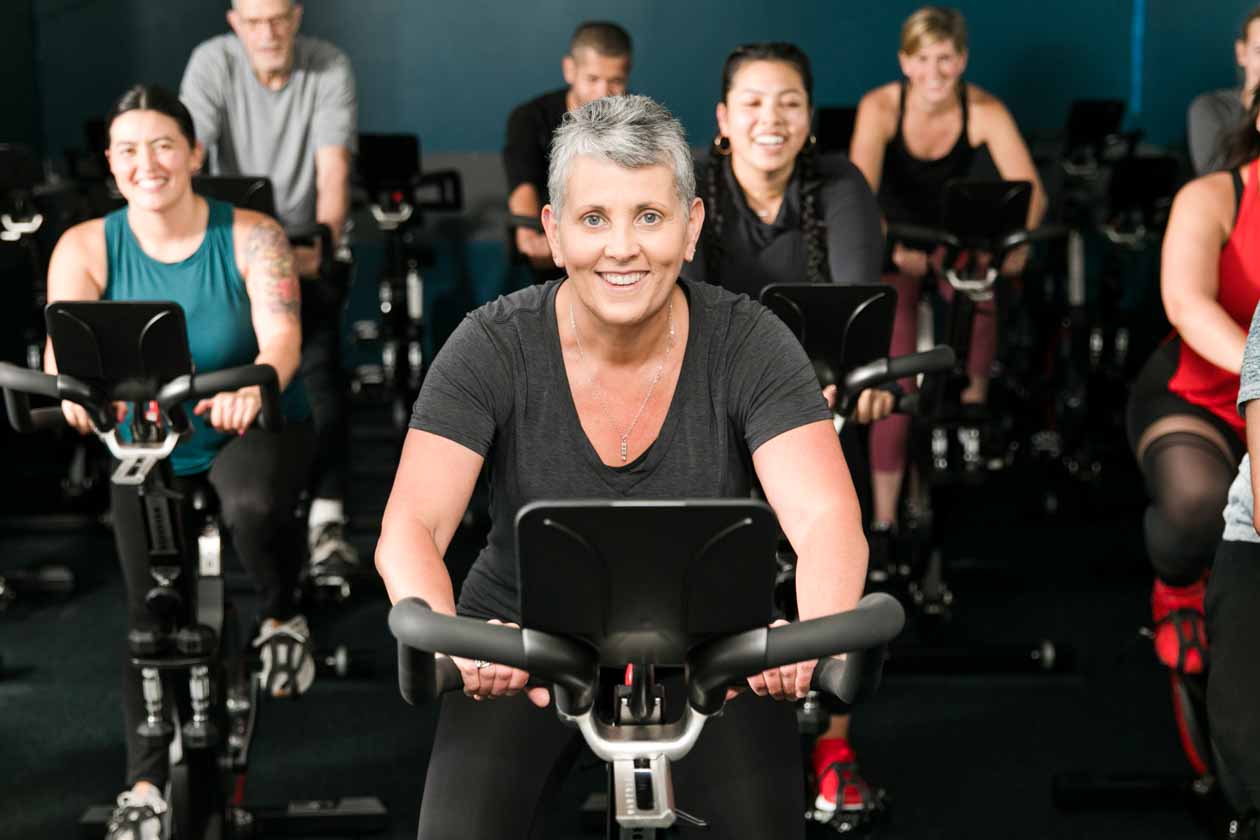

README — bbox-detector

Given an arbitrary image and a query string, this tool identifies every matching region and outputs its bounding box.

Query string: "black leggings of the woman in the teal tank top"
[111,423,314,787]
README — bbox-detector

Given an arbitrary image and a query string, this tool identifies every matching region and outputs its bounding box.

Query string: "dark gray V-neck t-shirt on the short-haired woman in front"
[411,280,830,620]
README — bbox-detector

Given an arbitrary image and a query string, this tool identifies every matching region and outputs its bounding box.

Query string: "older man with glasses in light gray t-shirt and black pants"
[180,0,358,578]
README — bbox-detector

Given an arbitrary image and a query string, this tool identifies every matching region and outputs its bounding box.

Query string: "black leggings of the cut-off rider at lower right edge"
[1207,542,1260,810]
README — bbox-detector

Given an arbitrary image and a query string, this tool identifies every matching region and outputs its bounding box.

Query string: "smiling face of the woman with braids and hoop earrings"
[717,60,810,174]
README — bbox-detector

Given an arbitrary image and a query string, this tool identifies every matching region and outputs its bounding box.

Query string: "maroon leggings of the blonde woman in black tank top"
[871,273,998,472]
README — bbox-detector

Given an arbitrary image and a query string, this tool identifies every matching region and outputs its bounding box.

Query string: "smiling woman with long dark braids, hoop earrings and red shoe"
[683,43,892,815]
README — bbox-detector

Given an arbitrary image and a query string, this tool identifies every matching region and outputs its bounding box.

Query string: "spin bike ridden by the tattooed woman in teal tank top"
[0,301,388,840]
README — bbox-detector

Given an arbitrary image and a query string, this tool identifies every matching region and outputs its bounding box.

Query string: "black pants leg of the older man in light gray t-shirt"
[299,269,350,501]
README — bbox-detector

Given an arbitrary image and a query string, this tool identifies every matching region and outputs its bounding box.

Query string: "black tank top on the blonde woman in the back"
[878,81,977,225]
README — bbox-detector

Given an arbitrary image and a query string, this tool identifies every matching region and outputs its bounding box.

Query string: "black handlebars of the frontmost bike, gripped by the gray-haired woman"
[389,593,906,714]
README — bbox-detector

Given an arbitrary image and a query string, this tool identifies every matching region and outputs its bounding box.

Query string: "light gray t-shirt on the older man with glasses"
[179,34,358,228]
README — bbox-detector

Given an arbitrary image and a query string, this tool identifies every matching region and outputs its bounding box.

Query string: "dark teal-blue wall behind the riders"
[17,0,1251,154]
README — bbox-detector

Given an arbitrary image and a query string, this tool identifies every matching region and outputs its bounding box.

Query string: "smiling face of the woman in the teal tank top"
[106,111,202,212]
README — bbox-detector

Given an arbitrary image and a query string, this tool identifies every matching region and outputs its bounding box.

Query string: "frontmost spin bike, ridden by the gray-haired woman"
[389,500,905,840]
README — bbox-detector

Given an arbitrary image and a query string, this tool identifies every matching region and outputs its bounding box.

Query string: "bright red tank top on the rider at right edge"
[1168,160,1260,440]
